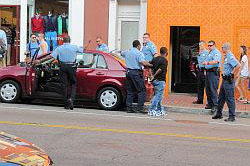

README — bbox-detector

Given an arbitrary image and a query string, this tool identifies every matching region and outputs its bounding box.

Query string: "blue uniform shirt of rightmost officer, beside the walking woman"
[223,52,239,76]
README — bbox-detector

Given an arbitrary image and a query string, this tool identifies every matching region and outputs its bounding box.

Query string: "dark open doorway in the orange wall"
[170,26,200,93]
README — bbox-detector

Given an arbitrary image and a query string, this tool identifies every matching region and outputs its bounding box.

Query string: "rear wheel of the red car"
[97,87,122,110]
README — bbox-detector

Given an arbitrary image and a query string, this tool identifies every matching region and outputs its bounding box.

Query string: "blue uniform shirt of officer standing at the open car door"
[52,43,84,63]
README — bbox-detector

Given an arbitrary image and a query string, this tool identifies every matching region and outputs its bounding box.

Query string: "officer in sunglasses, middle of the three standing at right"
[203,41,221,114]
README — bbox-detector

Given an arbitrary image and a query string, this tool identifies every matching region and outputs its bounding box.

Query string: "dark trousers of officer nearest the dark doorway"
[197,69,206,102]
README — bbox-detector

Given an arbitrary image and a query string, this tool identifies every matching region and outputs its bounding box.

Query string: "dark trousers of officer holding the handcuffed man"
[126,69,146,109]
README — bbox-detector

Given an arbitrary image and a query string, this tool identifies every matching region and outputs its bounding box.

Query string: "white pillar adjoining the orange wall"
[139,0,148,40]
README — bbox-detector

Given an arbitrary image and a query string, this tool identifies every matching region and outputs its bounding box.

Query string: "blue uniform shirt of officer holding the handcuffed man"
[122,47,145,70]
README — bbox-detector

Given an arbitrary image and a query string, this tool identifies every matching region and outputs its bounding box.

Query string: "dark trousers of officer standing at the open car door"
[60,63,77,104]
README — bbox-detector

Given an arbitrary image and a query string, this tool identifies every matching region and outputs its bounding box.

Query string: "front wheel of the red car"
[0,80,21,103]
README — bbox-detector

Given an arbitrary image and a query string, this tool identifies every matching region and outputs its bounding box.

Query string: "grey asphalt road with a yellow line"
[0,103,250,166]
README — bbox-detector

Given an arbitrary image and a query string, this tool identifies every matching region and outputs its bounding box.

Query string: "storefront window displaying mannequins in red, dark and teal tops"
[29,0,69,51]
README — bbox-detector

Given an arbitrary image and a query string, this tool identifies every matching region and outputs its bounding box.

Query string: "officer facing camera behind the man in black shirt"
[142,33,157,62]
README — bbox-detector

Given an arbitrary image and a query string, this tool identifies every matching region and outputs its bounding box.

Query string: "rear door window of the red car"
[76,53,98,68]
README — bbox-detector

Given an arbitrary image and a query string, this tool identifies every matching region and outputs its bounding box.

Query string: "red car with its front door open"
[0,51,153,110]
